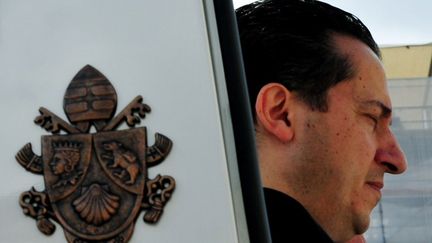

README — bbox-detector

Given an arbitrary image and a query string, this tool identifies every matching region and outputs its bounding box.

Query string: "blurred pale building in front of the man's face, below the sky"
[365,43,432,243]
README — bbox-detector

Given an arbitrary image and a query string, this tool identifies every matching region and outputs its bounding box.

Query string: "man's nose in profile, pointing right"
[375,129,407,174]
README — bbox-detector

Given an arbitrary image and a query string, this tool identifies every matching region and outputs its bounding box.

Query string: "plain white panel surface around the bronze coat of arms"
[0,0,245,243]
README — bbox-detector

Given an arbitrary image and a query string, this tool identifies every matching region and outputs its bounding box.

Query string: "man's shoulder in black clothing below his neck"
[264,188,333,243]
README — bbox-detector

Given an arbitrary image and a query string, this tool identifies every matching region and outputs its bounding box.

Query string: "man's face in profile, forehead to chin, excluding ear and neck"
[297,35,407,237]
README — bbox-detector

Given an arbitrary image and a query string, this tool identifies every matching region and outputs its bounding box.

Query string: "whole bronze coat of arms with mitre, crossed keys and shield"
[16,65,175,243]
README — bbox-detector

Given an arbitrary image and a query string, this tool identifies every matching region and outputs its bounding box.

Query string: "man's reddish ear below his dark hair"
[255,83,294,143]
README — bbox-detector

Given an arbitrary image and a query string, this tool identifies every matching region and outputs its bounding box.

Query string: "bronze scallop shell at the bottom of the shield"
[73,184,120,226]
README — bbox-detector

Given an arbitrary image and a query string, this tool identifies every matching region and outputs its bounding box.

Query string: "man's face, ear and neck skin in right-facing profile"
[256,34,406,241]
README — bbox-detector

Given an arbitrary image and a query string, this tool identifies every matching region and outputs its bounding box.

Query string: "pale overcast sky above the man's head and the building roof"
[233,0,432,46]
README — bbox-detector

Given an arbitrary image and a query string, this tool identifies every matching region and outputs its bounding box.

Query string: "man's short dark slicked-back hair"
[236,0,380,117]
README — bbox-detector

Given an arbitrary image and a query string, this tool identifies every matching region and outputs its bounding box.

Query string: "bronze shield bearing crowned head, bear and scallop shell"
[42,128,147,240]
